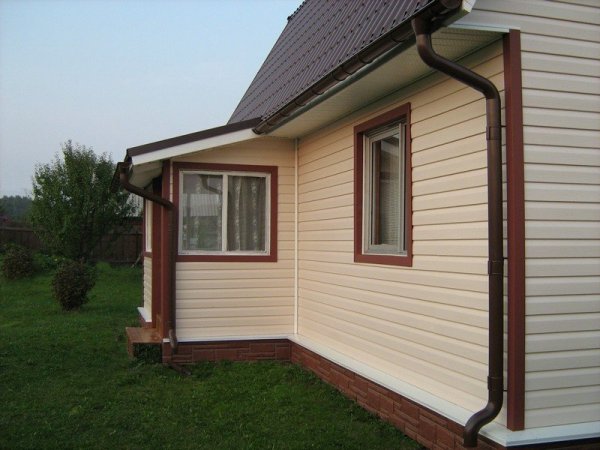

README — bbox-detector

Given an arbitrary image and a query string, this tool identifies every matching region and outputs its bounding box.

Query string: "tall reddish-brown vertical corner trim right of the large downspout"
[504,30,525,431]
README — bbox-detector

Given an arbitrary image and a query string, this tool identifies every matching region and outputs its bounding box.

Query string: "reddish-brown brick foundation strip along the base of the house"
[163,339,599,450]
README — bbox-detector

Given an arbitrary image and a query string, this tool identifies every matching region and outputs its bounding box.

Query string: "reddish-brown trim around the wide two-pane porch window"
[173,162,278,262]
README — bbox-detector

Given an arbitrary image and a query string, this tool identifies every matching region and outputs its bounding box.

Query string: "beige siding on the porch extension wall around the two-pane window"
[171,139,295,340]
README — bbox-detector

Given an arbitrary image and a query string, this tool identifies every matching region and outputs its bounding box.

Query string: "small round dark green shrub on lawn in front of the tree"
[52,260,96,311]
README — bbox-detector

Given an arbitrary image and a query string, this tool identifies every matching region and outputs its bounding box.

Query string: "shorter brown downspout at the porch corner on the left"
[117,162,177,352]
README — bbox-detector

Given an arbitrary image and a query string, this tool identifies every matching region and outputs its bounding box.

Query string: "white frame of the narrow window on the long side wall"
[362,121,407,256]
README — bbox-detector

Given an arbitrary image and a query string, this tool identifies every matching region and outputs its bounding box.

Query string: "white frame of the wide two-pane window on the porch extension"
[178,169,271,256]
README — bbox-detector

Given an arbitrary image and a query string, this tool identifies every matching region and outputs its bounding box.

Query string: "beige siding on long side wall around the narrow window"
[298,42,503,416]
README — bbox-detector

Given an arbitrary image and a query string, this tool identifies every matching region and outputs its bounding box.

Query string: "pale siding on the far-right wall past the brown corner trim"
[462,0,600,428]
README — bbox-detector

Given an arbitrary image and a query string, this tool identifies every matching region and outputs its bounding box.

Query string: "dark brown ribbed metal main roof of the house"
[229,0,436,123]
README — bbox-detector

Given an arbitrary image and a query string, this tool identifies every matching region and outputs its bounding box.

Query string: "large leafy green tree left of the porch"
[31,141,133,260]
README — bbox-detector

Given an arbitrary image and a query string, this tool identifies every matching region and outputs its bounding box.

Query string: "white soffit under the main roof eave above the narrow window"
[269,27,502,138]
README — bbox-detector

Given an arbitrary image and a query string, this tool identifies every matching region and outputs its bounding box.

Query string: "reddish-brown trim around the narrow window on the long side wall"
[354,103,413,267]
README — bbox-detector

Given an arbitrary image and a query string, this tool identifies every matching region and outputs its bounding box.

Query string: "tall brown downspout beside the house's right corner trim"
[412,12,504,447]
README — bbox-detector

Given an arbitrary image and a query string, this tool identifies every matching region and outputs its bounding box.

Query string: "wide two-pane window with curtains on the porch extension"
[176,164,277,261]
